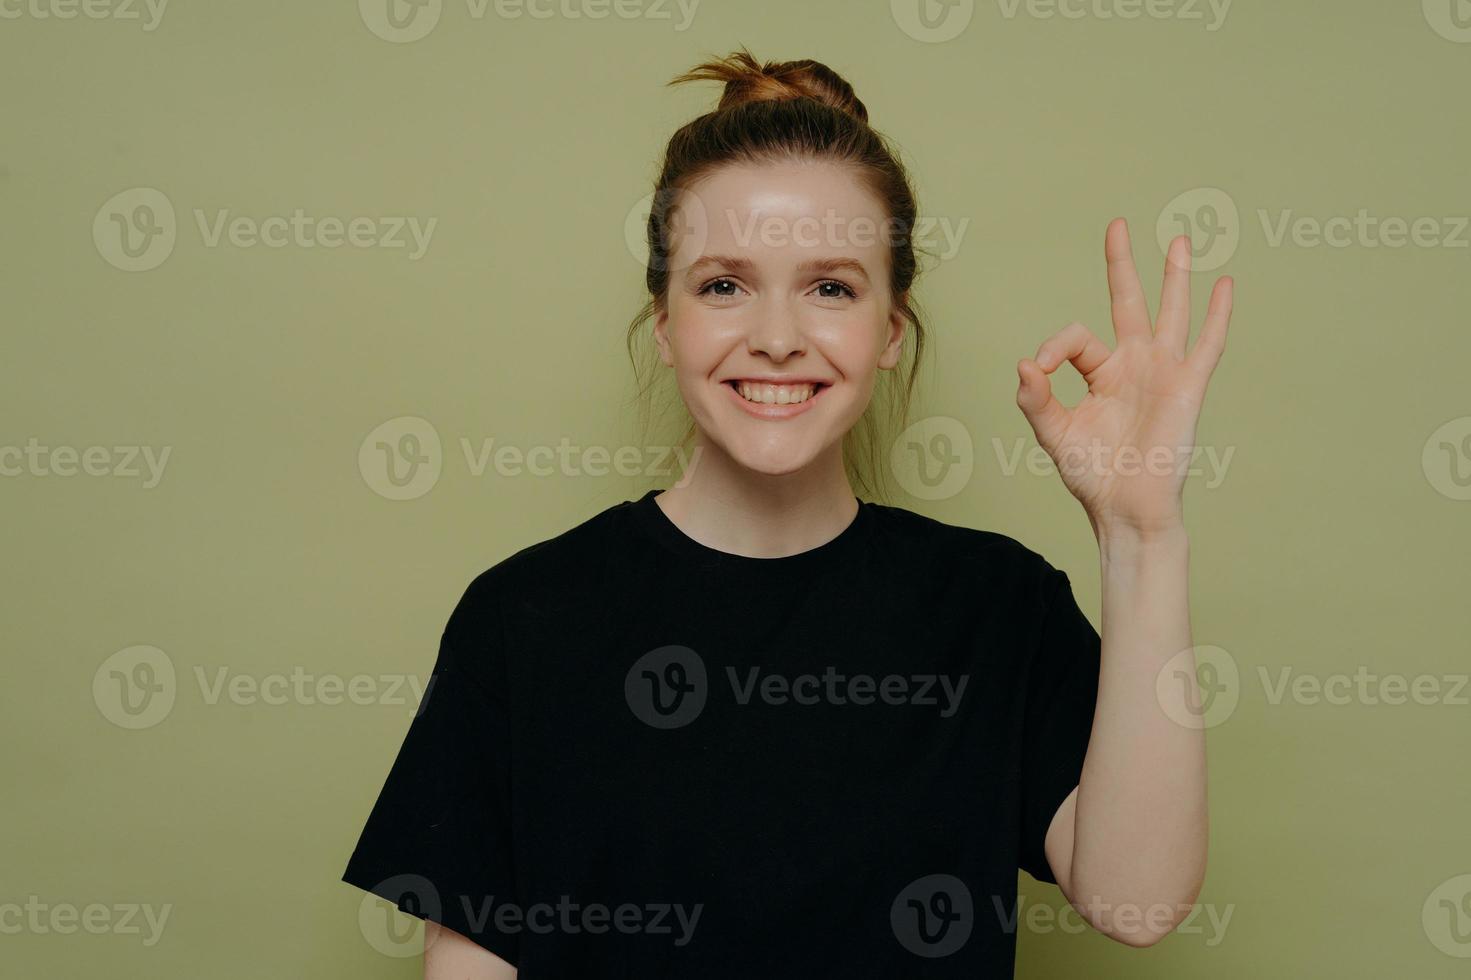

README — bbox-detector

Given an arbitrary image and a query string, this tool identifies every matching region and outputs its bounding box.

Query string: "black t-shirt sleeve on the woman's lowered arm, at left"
[341,586,518,964]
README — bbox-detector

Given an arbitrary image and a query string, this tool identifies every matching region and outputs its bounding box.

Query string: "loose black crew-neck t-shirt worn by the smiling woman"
[343,490,1099,980]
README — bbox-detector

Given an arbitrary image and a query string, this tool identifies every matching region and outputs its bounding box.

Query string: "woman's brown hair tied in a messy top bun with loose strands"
[627,47,925,500]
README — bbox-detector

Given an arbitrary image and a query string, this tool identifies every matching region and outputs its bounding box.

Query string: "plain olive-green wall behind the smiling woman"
[0,0,1471,980]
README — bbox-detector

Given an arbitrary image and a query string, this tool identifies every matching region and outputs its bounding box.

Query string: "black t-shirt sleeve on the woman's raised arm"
[1018,567,1102,884]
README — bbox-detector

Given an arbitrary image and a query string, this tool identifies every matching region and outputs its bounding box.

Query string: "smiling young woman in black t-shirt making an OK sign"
[343,50,1231,980]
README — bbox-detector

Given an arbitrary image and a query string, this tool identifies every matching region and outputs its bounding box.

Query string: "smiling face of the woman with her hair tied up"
[655,162,905,475]
